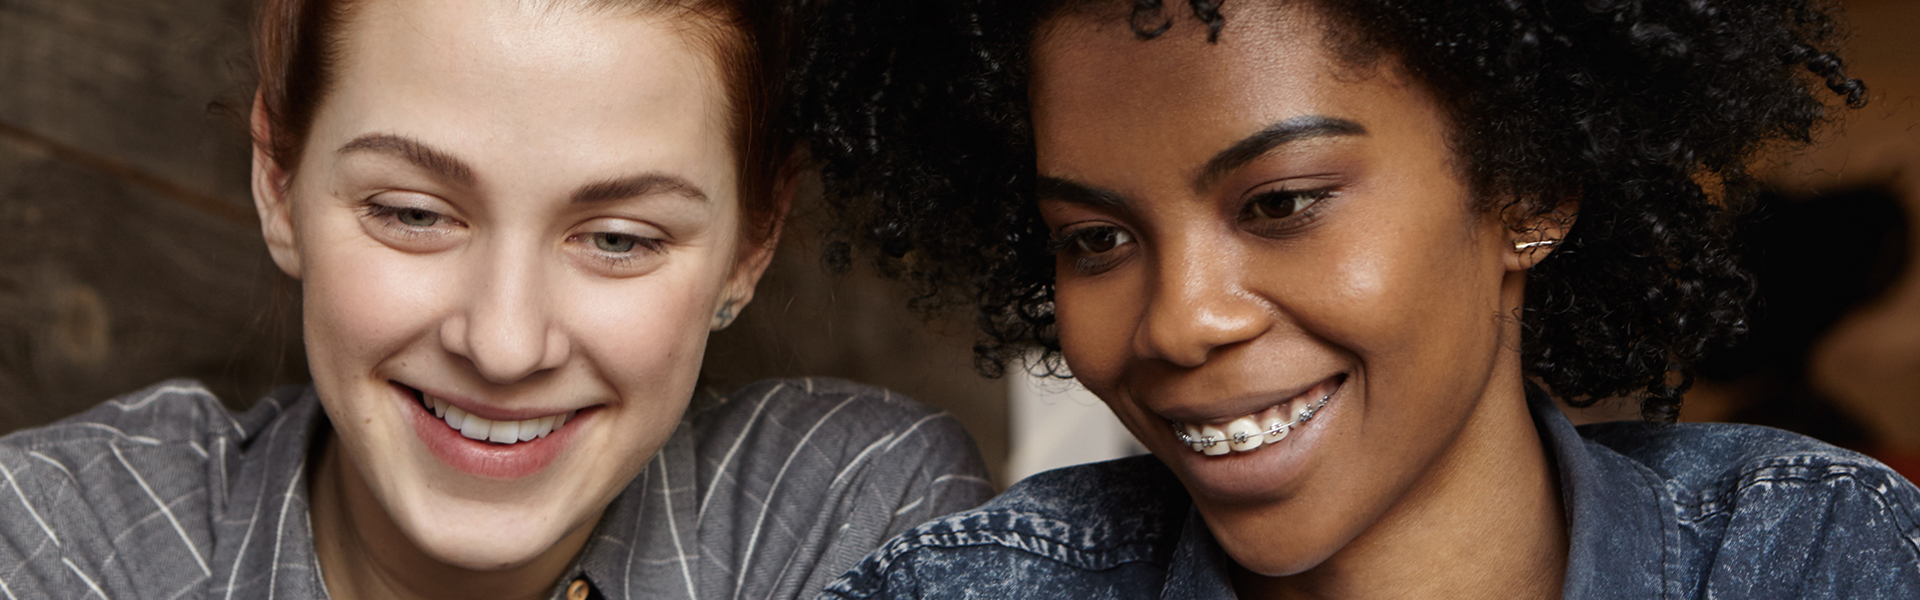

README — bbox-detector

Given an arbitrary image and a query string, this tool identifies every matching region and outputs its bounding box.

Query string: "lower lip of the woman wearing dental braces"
[1162,377,1354,502]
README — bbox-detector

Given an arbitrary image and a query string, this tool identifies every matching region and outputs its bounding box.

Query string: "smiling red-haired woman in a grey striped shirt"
[0,0,991,598]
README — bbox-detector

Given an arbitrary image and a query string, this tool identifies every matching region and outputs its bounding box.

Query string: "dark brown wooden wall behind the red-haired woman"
[0,0,1006,480]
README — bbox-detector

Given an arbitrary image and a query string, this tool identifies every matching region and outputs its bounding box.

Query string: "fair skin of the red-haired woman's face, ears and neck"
[253,2,774,598]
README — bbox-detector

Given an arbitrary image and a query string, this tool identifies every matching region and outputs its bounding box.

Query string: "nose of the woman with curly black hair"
[1135,244,1273,367]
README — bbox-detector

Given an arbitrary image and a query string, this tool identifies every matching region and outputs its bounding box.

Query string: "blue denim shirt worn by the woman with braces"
[822,394,1920,600]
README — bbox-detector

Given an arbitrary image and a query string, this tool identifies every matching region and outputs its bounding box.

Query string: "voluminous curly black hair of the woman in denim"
[793,0,1866,421]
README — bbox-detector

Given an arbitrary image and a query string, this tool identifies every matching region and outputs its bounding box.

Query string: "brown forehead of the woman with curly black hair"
[1031,2,1438,177]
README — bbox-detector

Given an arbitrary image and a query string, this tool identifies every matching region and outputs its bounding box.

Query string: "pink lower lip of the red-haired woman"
[401,390,597,479]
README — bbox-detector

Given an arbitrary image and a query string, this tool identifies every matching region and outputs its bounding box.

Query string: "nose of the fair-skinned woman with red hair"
[440,237,572,385]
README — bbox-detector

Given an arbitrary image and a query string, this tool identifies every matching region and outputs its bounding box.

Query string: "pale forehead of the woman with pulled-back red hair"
[315,0,730,188]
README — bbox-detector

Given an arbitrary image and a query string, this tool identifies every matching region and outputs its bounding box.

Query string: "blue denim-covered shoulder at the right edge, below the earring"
[1580,423,1920,598]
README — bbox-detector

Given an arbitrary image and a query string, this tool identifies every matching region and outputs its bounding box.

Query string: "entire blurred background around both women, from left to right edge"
[0,0,1920,487]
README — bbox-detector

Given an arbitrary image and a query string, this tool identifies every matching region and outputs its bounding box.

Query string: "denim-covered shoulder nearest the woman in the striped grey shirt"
[828,456,1190,598]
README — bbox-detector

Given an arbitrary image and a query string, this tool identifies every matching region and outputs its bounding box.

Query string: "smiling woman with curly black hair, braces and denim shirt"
[795,0,1920,598]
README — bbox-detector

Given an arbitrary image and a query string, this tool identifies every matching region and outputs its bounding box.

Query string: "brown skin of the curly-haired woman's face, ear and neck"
[1031,2,1572,598]
